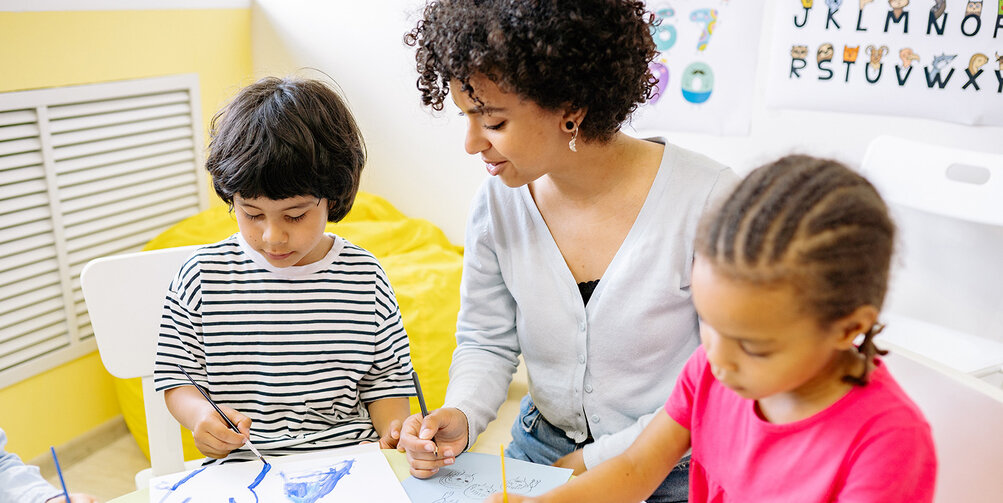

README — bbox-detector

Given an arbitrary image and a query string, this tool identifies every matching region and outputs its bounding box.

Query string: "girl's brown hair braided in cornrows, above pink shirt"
[697,156,895,386]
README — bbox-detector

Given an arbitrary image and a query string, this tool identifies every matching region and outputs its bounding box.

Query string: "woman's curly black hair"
[404,0,657,142]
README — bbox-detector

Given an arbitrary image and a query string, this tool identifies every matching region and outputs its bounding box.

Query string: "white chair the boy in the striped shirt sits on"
[80,246,200,489]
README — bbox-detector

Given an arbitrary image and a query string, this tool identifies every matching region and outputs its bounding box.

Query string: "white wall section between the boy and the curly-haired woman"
[251,0,485,244]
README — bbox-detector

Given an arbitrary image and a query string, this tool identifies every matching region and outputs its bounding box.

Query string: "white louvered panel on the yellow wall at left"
[0,75,208,388]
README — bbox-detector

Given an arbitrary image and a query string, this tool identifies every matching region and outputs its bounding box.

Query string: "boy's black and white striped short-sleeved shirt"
[154,233,414,454]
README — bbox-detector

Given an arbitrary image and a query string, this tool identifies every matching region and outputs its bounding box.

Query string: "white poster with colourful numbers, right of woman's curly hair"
[632,0,762,135]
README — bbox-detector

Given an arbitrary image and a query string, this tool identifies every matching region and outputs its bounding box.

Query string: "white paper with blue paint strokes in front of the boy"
[149,444,409,503]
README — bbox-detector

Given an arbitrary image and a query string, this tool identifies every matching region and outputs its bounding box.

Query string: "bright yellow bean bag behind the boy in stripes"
[115,192,462,460]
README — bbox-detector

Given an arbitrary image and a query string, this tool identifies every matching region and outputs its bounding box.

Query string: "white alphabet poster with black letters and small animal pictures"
[766,0,1003,125]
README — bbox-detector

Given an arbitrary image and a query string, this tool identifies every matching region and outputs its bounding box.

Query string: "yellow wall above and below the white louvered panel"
[0,9,252,459]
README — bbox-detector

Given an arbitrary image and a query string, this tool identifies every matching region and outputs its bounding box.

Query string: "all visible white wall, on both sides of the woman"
[252,0,1003,243]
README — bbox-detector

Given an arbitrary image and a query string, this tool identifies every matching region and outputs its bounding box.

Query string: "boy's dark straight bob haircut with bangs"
[206,77,366,222]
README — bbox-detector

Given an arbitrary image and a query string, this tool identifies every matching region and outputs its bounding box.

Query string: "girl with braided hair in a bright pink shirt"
[491,156,937,503]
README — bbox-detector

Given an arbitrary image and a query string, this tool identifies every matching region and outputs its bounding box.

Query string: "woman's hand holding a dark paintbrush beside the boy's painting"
[397,408,468,479]
